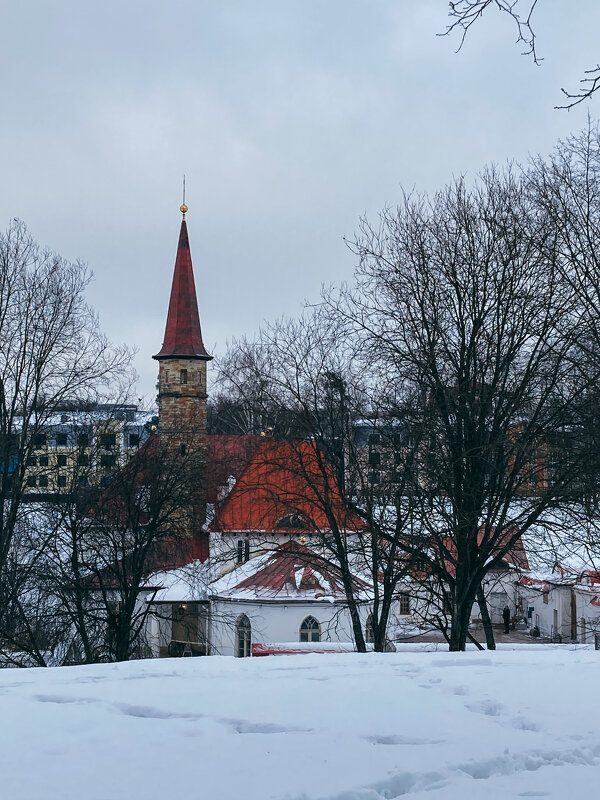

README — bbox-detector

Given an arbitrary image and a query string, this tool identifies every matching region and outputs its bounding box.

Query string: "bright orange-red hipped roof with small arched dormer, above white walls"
[209,437,365,533]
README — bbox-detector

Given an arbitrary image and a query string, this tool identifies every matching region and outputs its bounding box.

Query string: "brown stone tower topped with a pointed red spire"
[153,205,212,538]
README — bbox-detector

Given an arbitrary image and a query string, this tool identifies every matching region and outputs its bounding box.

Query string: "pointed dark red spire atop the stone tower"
[152,214,212,361]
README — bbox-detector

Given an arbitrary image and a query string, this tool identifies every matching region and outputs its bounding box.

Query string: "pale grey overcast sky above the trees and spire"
[0,0,600,406]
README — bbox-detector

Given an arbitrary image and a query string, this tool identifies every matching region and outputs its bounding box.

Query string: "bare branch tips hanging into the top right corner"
[442,0,600,109]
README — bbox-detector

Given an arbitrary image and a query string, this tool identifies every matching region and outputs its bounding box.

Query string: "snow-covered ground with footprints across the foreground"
[0,645,600,800]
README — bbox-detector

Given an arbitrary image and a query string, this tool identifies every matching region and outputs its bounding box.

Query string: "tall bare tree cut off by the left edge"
[0,221,131,600]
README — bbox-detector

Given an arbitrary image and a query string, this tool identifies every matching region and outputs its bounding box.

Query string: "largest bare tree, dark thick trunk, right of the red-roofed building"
[328,170,597,650]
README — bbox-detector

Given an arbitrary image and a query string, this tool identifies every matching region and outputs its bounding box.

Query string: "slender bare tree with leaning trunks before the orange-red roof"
[218,307,418,651]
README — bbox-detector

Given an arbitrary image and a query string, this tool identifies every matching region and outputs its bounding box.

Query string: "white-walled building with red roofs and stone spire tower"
[142,205,372,656]
